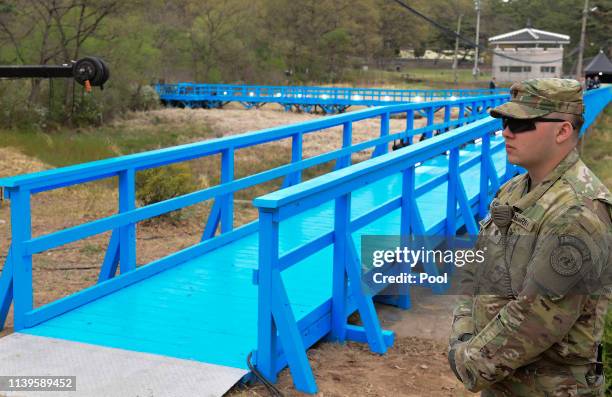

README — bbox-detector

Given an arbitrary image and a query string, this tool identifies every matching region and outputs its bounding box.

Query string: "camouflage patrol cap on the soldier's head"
[489,79,584,119]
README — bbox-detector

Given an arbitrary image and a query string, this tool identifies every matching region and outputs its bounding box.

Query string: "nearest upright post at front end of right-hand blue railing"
[257,209,278,382]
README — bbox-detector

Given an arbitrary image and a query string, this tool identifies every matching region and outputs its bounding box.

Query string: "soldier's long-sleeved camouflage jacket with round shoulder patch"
[451,150,612,396]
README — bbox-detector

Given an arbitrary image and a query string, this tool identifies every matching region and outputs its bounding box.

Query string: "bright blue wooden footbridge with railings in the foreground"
[0,87,612,396]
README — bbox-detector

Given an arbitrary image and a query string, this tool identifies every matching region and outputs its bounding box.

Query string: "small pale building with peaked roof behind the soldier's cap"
[489,27,570,82]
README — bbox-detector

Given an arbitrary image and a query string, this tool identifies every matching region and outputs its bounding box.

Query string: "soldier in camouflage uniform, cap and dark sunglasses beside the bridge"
[449,79,612,396]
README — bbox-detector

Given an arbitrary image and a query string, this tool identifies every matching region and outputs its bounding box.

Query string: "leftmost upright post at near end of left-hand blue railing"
[9,189,33,331]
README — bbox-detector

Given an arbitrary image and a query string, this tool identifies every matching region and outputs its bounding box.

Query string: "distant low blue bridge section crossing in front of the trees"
[155,83,508,114]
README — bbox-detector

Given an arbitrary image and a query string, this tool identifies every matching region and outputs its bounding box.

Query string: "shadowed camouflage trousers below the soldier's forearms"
[481,360,606,397]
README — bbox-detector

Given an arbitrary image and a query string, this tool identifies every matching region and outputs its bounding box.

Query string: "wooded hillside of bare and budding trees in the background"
[0,0,612,125]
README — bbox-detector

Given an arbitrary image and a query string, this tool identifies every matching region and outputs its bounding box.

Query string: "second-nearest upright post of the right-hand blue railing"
[331,194,351,343]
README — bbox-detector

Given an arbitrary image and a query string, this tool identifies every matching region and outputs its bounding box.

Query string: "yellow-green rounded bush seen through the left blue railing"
[136,164,197,221]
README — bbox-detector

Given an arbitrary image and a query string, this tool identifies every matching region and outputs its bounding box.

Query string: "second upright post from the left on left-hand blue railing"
[119,168,136,273]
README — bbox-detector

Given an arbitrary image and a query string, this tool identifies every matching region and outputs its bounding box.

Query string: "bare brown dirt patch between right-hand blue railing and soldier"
[228,289,475,397]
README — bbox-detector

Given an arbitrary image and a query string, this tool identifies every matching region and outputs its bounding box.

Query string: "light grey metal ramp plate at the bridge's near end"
[0,333,248,397]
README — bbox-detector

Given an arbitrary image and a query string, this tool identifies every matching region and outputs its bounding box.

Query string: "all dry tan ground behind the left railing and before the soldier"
[0,107,467,397]
